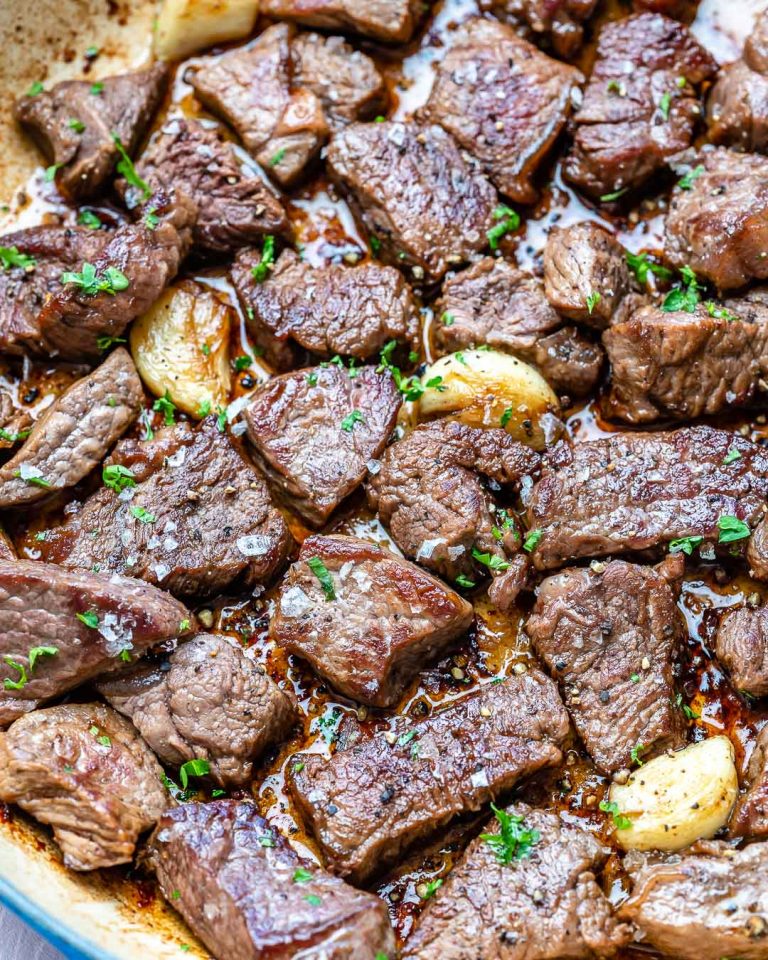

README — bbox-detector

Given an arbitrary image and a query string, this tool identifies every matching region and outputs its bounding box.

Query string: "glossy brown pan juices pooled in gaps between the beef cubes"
[0,0,768,957]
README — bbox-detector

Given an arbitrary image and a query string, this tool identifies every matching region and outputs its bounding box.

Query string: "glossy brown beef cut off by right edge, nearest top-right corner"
[707,11,768,153]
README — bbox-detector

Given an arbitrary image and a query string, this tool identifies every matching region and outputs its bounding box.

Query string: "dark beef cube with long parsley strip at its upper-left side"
[126,117,288,253]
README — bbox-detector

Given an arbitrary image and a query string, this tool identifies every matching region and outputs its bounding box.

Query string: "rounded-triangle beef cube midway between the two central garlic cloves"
[245,364,401,527]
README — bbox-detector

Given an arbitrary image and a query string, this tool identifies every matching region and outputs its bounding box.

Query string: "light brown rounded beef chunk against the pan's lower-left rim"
[0,703,169,870]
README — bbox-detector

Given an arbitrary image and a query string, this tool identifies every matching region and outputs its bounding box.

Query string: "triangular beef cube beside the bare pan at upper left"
[15,63,168,200]
